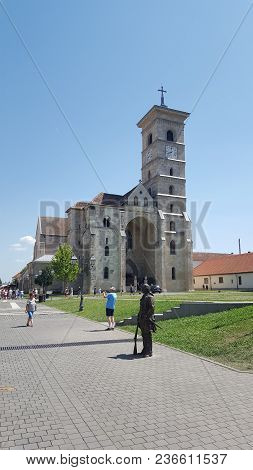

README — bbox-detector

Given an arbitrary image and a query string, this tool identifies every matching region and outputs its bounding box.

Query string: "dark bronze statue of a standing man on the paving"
[138,284,156,357]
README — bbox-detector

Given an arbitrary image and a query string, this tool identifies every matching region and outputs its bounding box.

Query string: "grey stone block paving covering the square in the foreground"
[0,301,253,449]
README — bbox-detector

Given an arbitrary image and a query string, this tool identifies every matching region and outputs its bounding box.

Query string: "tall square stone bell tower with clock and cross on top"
[137,87,192,291]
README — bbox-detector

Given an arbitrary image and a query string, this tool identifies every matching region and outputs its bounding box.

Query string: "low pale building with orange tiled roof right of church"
[193,253,253,290]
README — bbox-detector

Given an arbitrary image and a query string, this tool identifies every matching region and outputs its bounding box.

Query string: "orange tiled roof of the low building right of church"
[193,253,253,276]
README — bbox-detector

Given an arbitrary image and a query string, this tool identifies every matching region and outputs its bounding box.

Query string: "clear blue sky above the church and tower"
[0,0,253,280]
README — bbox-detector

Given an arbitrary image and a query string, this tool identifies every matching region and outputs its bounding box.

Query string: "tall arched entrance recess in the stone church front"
[126,217,156,286]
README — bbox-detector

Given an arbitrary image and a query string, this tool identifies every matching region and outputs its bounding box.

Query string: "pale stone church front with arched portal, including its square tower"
[67,105,192,292]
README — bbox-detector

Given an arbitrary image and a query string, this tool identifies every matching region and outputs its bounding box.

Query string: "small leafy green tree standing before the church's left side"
[51,243,79,291]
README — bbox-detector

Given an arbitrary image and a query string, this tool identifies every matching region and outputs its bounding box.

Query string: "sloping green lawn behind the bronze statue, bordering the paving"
[124,306,253,371]
